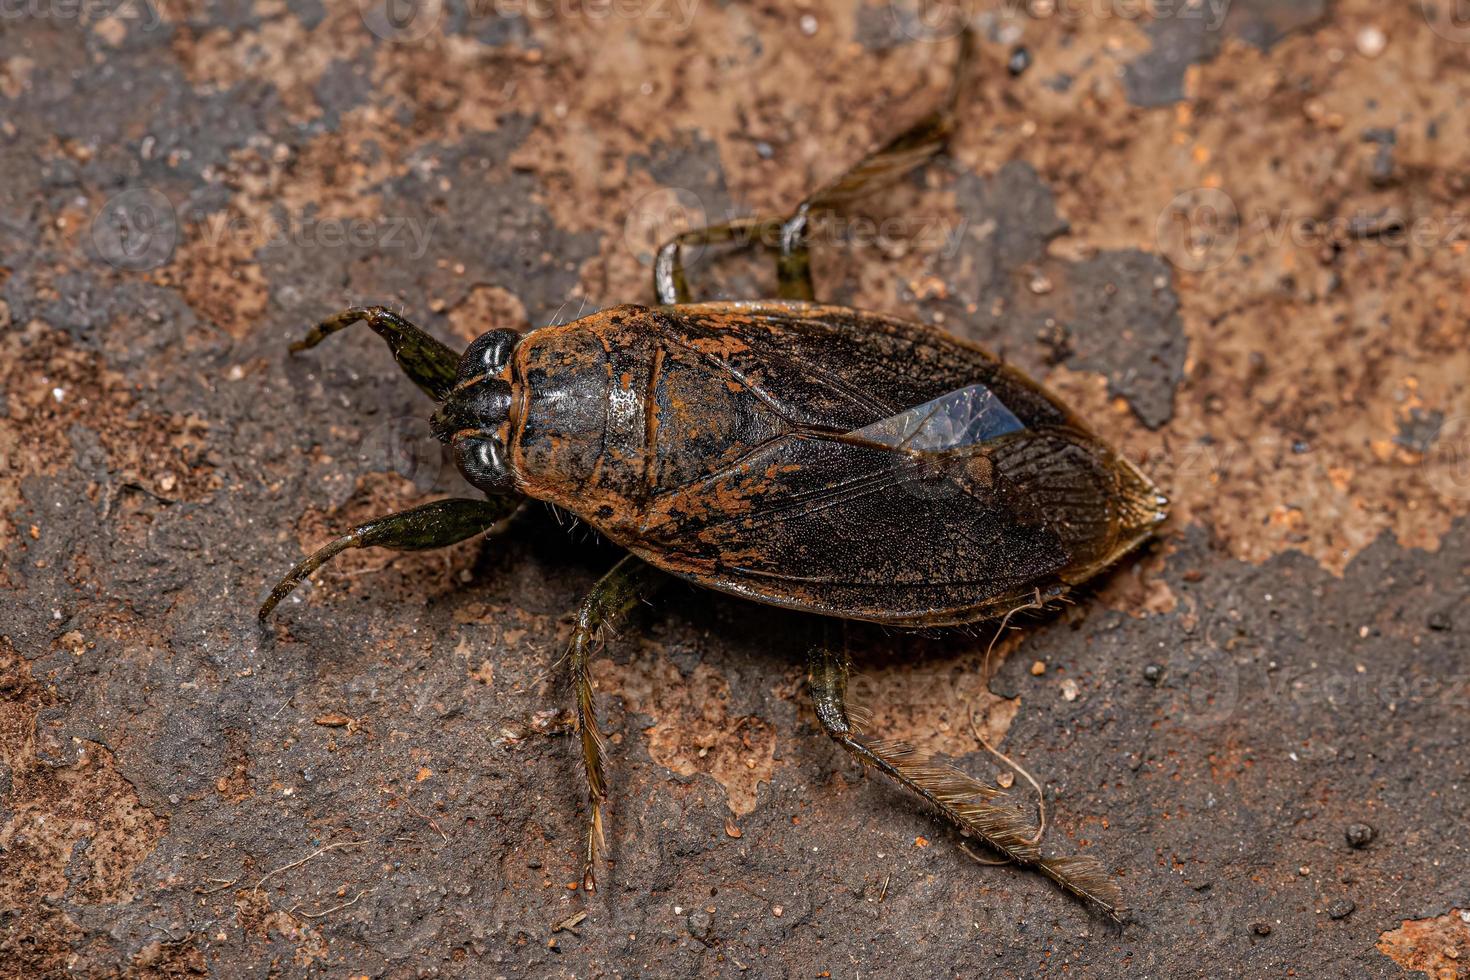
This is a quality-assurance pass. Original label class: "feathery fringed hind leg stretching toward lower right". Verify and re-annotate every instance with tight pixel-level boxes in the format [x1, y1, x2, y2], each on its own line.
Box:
[807, 648, 1123, 921]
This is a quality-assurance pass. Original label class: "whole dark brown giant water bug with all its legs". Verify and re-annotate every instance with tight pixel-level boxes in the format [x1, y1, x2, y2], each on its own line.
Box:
[260, 36, 1166, 918]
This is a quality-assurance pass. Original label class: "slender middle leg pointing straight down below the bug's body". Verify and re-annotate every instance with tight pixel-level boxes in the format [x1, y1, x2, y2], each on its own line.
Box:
[567, 555, 664, 892]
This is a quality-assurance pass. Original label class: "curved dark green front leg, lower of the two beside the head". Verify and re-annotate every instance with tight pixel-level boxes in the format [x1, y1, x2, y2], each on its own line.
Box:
[257, 497, 520, 626]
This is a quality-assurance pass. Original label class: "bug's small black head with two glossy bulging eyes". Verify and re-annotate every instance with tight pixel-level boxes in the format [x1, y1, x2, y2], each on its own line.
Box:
[431, 331, 520, 494]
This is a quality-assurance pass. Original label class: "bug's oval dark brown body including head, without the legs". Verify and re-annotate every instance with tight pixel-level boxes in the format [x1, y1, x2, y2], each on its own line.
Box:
[435, 301, 1160, 626]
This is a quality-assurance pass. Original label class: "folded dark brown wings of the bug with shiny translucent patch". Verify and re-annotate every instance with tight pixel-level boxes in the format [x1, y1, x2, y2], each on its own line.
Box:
[605, 304, 1151, 624]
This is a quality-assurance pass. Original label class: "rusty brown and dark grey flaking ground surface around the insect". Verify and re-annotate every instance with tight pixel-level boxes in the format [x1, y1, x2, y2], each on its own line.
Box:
[0, 0, 1470, 977]
